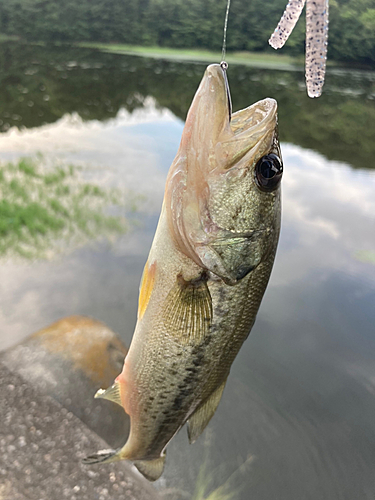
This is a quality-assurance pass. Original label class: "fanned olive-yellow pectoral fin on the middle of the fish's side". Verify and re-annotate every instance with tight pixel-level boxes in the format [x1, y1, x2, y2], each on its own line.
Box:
[162, 274, 212, 344]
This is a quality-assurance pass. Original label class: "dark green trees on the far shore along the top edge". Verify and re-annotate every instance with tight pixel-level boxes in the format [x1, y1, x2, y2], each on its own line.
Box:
[0, 0, 375, 64]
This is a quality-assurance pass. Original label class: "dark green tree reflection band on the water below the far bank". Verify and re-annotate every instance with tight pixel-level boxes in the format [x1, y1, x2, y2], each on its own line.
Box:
[0, 43, 375, 168]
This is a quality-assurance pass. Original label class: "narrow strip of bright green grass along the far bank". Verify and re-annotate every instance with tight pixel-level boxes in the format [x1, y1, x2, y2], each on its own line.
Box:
[76, 42, 303, 70]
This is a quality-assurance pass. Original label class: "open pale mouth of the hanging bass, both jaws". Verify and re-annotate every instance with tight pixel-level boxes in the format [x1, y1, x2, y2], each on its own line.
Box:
[181, 64, 277, 166]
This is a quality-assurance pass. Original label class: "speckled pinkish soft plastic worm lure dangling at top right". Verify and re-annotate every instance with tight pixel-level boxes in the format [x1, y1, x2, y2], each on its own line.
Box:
[269, 0, 328, 97]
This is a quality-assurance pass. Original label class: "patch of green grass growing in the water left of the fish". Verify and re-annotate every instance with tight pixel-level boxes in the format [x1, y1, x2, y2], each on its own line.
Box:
[0, 157, 137, 258]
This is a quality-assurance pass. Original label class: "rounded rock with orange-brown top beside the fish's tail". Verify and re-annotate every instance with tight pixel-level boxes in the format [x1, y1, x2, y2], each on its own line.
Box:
[0, 316, 129, 448]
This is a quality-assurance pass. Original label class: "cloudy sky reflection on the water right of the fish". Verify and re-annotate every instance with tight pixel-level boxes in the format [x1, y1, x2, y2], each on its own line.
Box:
[166, 145, 375, 500]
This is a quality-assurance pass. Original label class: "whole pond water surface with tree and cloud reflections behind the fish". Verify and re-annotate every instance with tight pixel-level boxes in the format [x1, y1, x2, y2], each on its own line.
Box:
[0, 44, 375, 500]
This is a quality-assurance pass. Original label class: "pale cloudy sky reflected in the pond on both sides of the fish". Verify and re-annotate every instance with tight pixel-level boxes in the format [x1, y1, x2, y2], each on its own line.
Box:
[0, 100, 375, 500]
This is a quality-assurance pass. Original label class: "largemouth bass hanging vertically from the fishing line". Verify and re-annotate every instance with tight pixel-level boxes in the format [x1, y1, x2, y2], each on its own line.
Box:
[84, 64, 283, 481]
